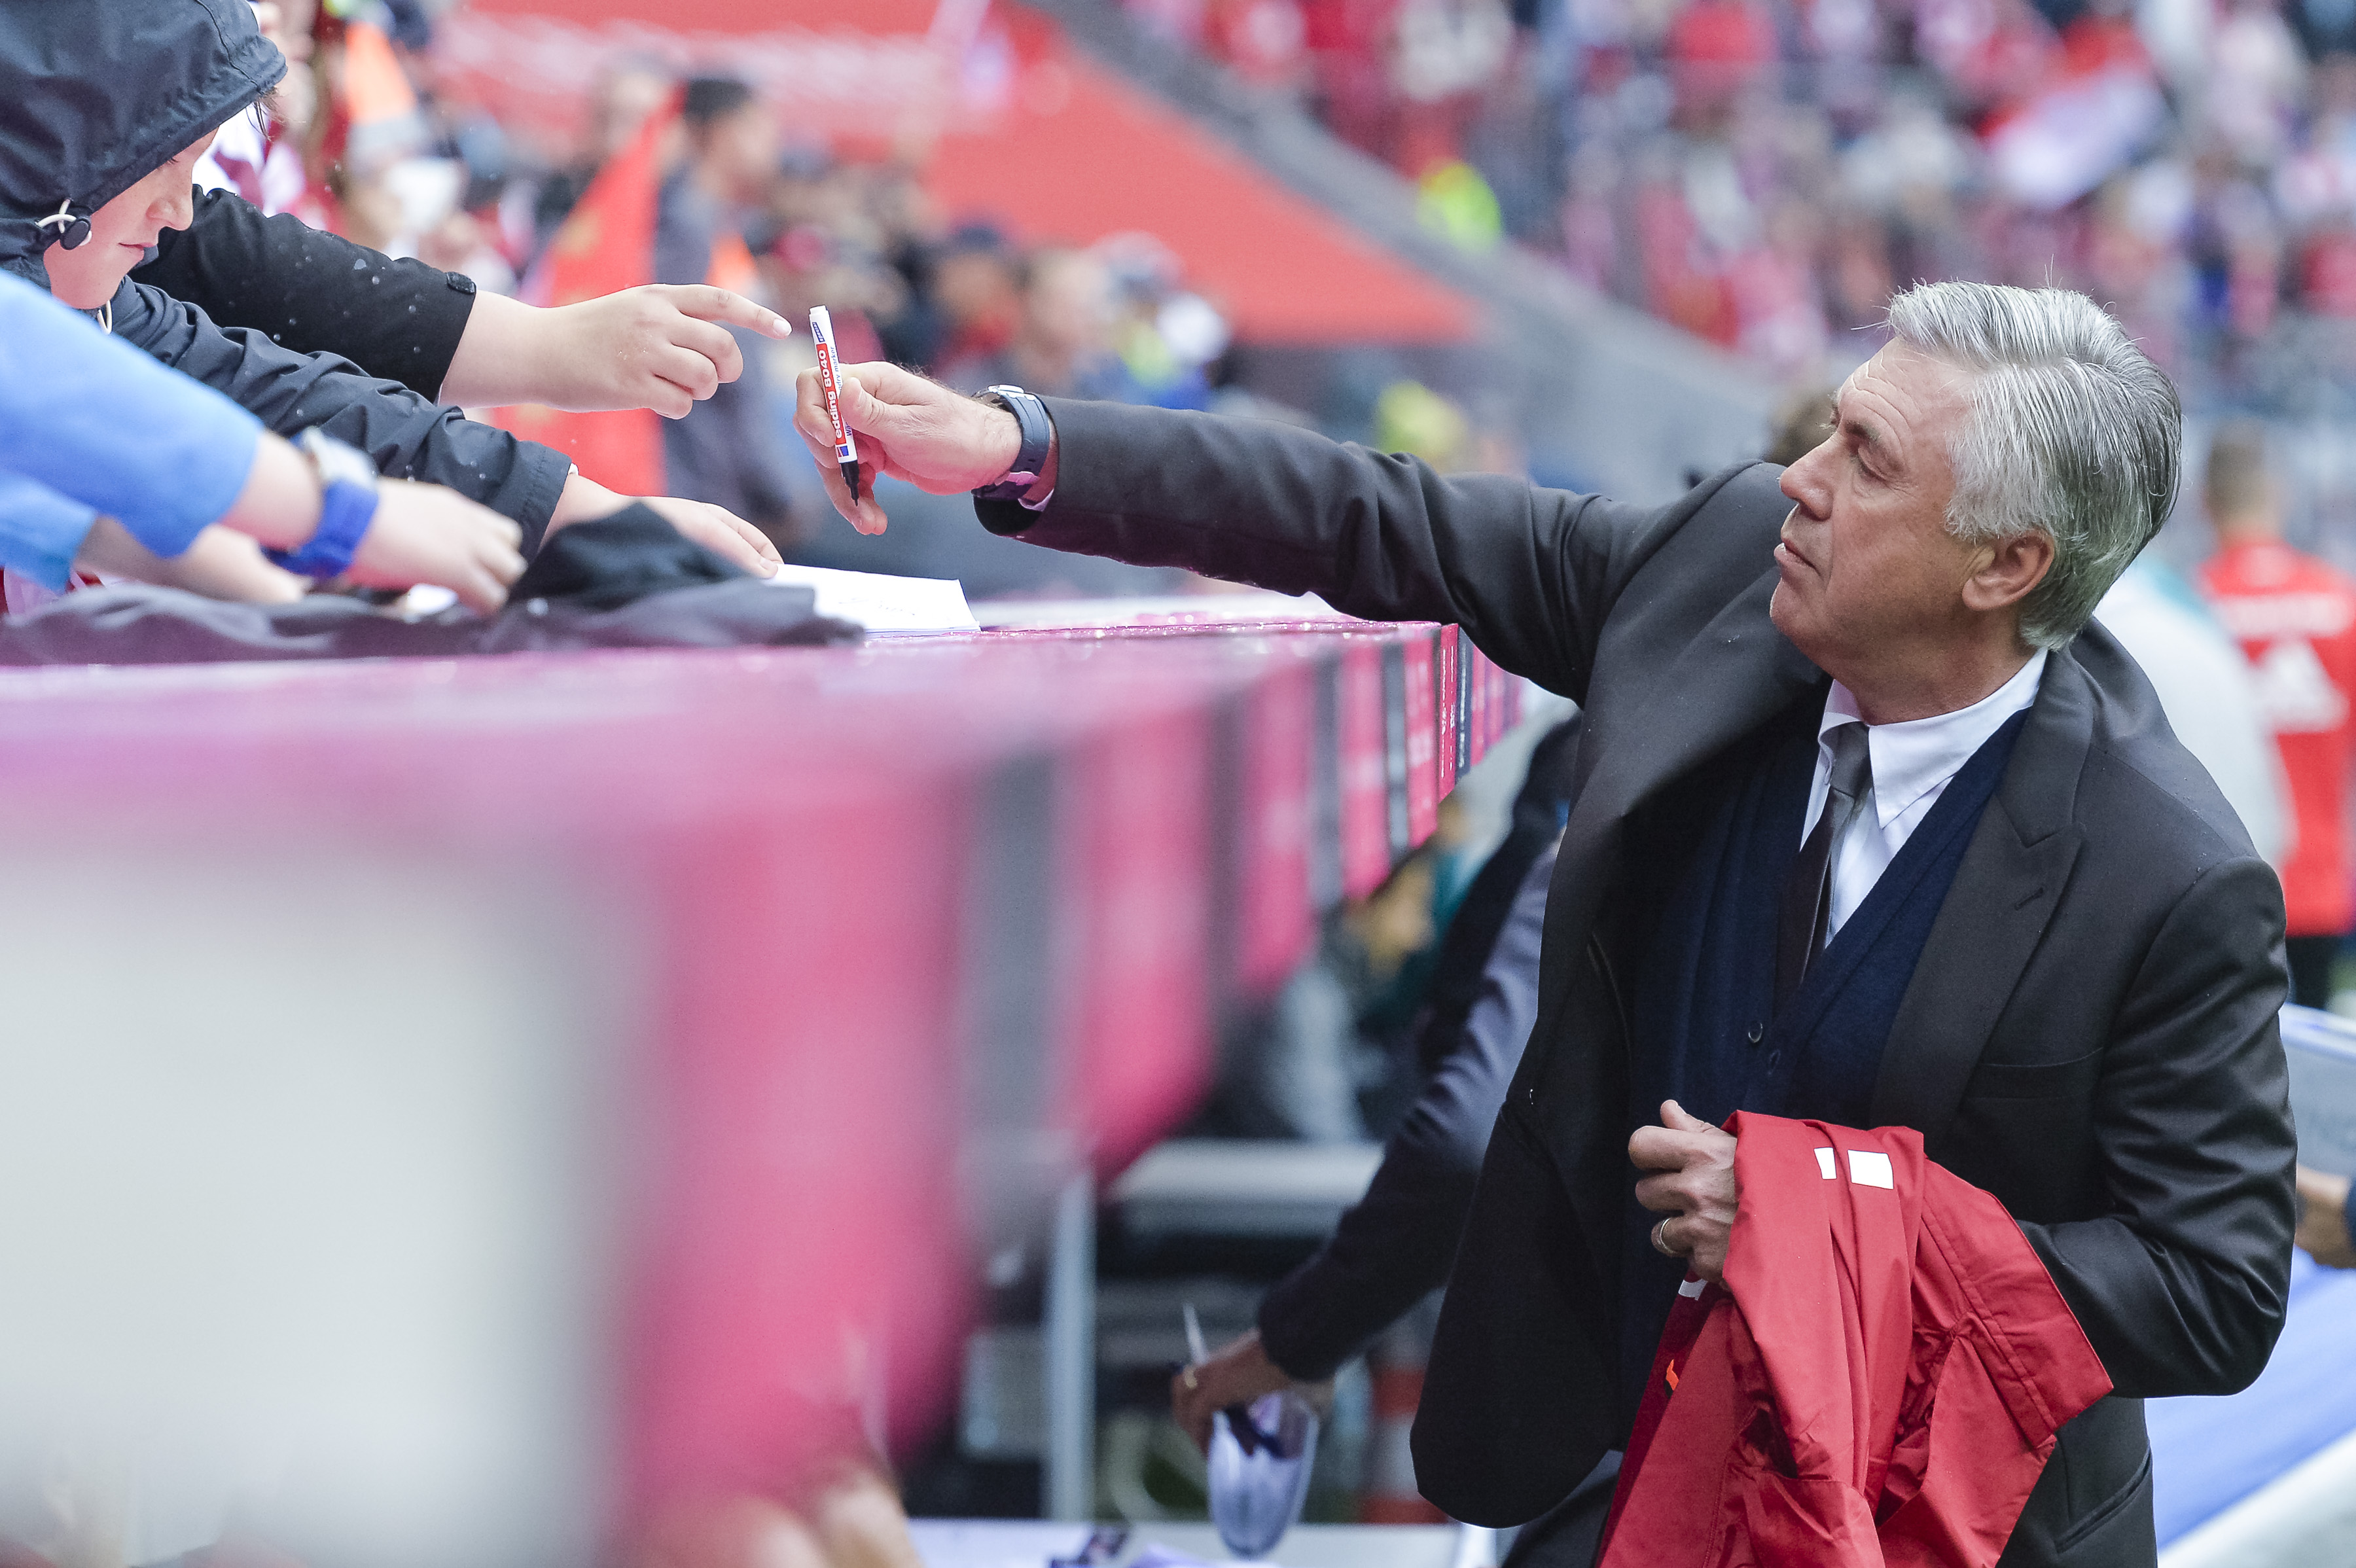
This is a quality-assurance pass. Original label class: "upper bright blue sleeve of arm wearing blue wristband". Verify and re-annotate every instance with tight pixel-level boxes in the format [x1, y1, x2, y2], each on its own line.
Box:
[0, 276, 262, 556]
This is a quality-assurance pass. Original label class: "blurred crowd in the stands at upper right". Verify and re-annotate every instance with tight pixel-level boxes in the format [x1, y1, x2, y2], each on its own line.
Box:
[1124, 0, 2356, 395]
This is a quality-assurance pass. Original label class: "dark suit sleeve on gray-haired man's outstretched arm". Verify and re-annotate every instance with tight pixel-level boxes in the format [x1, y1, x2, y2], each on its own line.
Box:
[975, 398, 1715, 702]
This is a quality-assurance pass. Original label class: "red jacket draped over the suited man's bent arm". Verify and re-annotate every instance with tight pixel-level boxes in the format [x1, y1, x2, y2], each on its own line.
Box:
[1602, 1114, 2111, 1568]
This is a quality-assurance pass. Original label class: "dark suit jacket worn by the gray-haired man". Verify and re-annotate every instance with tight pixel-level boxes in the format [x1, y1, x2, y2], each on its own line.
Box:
[982, 402, 2293, 1563]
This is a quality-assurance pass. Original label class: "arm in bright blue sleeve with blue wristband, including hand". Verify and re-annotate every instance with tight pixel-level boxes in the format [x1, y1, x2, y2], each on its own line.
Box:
[0, 273, 523, 615]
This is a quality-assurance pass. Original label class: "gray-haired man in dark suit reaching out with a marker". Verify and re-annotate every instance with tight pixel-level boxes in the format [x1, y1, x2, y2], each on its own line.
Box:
[796, 283, 2293, 1563]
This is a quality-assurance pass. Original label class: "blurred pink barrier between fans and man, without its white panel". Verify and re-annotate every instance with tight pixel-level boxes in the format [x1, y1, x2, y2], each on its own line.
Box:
[0, 622, 1517, 1530]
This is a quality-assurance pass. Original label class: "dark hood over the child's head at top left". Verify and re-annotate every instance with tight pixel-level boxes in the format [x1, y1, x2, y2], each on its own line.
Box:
[0, 0, 287, 287]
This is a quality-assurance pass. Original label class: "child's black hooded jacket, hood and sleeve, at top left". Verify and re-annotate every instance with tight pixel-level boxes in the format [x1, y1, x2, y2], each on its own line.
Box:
[0, 0, 570, 553]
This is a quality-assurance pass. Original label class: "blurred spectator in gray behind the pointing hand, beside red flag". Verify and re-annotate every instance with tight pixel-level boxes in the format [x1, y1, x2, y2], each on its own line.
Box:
[655, 75, 798, 541]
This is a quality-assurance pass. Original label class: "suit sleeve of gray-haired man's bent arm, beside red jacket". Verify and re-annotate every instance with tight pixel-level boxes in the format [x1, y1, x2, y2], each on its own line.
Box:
[2022, 857, 2294, 1399]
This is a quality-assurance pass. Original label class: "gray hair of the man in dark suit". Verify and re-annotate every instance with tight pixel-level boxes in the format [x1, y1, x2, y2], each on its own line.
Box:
[1889, 283, 2184, 647]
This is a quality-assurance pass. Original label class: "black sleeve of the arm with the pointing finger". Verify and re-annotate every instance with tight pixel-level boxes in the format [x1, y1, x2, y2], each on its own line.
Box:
[132, 190, 474, 402]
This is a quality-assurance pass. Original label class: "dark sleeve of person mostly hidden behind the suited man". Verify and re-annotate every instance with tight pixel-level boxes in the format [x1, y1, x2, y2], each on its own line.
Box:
[1260, 846, 1555, 1382]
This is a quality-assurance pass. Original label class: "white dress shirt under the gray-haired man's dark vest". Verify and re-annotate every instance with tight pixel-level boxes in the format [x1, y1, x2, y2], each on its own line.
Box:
[1800, 647, 2045, 942]
